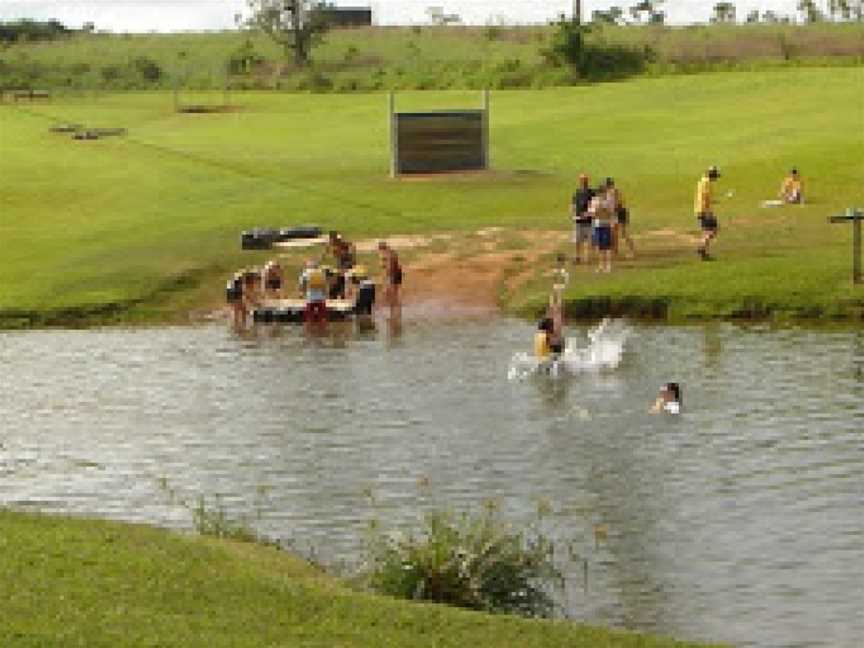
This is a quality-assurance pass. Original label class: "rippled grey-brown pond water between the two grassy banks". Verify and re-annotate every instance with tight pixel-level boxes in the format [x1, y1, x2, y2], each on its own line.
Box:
[0, 313, 864, 648]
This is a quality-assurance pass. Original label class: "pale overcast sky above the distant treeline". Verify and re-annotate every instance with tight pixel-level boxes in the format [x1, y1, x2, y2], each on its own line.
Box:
[0, 0, 827, 32]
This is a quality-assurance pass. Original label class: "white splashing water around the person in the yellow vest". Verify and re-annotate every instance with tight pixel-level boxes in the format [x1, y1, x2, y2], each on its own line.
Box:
[507, 317, 631, 380]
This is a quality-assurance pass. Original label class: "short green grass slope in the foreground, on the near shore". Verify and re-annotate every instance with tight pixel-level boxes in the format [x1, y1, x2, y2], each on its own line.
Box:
[0, 510, 724, 648]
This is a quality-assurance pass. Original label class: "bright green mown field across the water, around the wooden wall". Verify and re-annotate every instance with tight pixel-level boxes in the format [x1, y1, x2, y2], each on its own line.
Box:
[0, 67, 864, 327]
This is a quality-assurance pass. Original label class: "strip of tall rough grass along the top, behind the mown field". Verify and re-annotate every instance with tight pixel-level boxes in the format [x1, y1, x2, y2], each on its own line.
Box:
[0, 23, 864, 92]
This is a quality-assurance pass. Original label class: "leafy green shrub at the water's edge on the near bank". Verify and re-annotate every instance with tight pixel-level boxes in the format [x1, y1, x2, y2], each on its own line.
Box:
[367, 504, 563, 617]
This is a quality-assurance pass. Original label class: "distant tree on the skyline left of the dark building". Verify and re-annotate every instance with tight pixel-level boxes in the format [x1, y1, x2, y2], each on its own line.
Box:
[245, 0, 329, 66]
